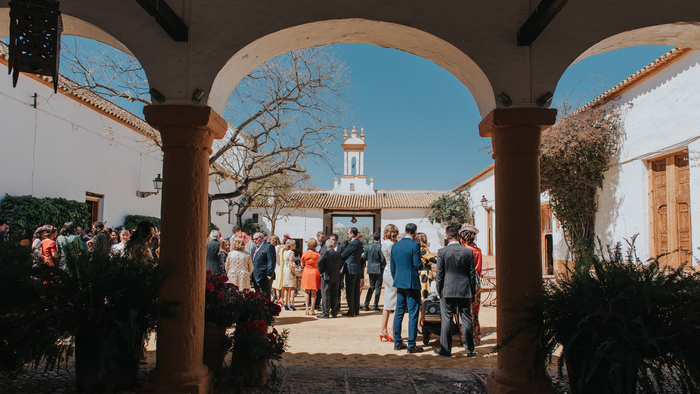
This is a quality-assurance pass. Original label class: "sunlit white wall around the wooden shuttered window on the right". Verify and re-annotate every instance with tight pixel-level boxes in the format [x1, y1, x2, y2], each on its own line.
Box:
[596, 51, 700, 259]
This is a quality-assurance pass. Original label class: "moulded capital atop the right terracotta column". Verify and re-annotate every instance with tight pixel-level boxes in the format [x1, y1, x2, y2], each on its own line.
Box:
[479, 108, 557, 137]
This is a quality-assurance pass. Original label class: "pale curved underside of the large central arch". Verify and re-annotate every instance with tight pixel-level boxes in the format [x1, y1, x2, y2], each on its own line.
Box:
[207, 19, 496, 117]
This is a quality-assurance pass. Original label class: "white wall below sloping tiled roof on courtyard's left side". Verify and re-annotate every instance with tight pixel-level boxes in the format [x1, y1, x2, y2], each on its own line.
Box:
[0, 70, 167, 226]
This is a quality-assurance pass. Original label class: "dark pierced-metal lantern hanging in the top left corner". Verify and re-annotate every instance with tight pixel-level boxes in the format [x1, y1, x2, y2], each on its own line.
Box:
[7, 0, 63, 93]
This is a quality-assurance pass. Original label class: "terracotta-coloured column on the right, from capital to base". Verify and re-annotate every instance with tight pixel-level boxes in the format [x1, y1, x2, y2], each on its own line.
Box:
[479, 108, 557, 394]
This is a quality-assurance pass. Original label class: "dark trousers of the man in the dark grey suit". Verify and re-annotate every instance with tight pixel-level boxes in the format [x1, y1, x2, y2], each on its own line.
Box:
[440, 297, 474, 354]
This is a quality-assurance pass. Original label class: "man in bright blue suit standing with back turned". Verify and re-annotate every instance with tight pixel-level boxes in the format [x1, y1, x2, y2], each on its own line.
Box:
[390, 223, 423, 353]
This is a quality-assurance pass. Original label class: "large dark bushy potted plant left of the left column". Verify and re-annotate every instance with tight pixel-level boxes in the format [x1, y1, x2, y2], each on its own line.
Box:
[2, 245, 158, 391]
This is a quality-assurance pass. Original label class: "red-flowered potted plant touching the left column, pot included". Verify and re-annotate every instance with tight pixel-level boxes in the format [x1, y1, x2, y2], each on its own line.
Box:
[203, 270, 238, 375]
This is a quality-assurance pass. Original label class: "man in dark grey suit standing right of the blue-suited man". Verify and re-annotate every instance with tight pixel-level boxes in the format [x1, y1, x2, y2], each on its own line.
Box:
[434, 226, 476, 357]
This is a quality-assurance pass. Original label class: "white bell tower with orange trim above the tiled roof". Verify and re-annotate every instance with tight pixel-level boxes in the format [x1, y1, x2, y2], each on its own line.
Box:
[333, 126, 374, 194]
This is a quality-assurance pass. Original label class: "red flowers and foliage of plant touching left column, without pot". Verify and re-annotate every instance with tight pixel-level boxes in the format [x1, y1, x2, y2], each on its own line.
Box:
[204, 270, 240, 327]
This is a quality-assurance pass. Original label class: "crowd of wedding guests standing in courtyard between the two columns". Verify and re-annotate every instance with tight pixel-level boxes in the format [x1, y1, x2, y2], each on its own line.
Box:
[206, 223, 482, 357]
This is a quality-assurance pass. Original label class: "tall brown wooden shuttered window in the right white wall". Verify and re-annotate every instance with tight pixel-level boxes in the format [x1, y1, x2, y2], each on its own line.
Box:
[648, 152, 692, 268]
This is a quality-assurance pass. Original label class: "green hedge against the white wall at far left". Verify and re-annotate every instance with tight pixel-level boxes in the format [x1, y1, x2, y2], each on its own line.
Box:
[0, 194, 90, 233]
